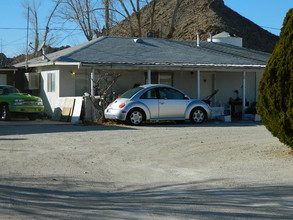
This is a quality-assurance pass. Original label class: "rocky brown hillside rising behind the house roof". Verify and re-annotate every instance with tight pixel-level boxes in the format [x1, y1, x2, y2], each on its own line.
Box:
[111, 0, 279, 52]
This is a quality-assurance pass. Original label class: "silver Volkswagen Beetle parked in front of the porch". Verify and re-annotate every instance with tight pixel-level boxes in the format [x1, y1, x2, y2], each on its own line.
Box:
[105, 84, 211, 125]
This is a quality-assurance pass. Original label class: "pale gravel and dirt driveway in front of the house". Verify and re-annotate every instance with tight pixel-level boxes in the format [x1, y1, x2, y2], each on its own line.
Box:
[0, 121, 293, 219]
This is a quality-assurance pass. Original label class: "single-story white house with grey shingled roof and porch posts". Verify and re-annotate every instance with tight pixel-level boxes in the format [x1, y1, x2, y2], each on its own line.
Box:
[16, 33, 270, 121]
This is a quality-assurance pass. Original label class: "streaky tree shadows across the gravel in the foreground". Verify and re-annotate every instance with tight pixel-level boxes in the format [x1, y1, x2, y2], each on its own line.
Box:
[0, 177, 293, 220]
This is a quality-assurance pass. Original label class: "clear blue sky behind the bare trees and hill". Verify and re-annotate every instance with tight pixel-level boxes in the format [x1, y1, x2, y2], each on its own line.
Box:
[0, 0, 293, 58]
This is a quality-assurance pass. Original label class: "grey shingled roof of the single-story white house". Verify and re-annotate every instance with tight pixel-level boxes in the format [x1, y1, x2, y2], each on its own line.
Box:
[15, 37, 270, 69]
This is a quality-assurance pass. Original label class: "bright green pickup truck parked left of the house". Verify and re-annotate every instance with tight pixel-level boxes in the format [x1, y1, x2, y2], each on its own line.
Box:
[0, 85, 44, 121]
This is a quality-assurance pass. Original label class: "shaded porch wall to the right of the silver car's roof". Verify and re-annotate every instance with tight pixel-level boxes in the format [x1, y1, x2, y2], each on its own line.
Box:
[174, 71, 262, 106]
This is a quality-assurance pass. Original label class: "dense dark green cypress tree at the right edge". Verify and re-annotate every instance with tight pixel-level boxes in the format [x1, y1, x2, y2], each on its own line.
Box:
[257, 9, 293, 150]
